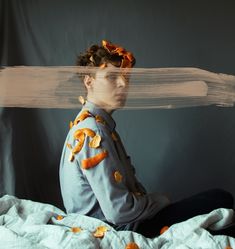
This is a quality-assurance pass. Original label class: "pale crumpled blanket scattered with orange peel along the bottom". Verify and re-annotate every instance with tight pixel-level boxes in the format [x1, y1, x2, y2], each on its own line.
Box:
[0, 195, 235, 249]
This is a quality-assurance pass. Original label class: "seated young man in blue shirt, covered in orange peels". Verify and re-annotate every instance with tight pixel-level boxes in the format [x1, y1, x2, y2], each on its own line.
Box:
[60, 40, 233, 237]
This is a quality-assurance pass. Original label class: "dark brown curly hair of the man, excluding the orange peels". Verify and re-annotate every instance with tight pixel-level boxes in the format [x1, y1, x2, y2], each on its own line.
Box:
[76, 41, 136, 79]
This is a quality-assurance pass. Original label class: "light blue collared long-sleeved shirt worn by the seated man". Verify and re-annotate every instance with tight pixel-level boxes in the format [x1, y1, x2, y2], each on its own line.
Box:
[60, 101, 169, 230]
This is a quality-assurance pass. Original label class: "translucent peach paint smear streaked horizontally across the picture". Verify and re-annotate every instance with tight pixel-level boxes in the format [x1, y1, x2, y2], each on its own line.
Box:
[0, 66, 235, 109]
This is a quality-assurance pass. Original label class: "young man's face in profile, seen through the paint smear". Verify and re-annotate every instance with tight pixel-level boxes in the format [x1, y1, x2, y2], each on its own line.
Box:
[84, 63, 129, 111]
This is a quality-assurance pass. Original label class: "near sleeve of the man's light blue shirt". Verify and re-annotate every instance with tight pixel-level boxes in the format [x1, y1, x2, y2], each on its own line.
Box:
[76, 126, 169, 225]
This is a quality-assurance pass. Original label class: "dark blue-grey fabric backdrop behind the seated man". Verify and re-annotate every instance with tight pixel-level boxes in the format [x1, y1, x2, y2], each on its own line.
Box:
[0, 0, 235, 208]
